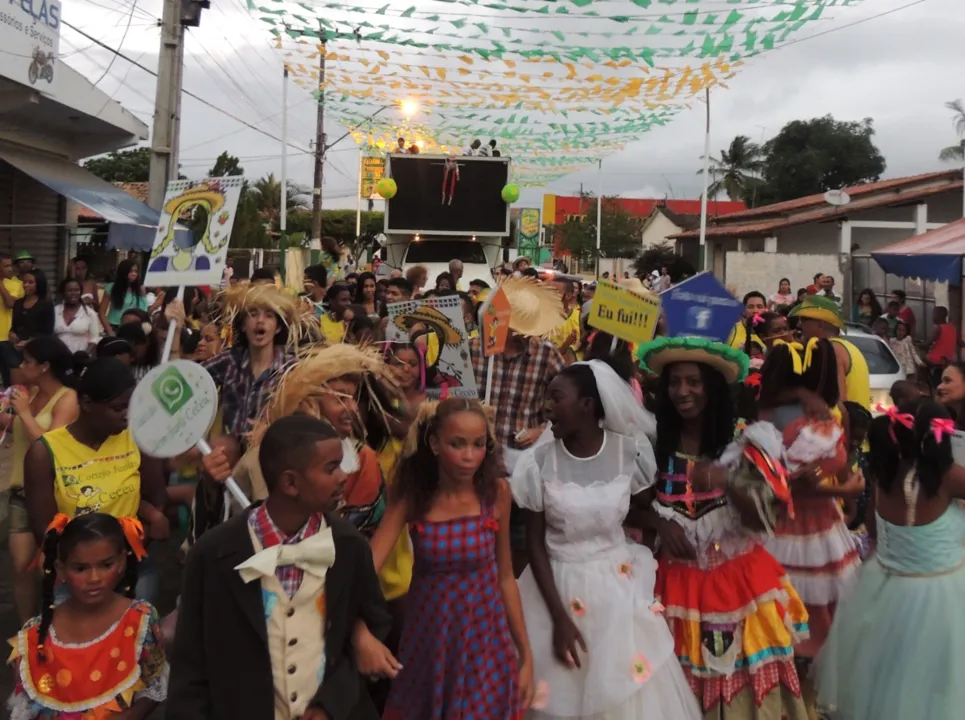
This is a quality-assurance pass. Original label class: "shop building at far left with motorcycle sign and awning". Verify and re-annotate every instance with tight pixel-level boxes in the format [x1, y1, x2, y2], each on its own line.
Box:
[0, 8, 151, 282]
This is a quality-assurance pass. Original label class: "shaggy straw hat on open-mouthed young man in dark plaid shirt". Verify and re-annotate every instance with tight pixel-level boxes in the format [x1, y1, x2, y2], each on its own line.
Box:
[218, 283, 323, 350]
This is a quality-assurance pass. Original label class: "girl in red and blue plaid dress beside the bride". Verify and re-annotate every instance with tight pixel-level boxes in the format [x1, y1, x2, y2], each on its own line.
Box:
[372, 398, 533, 720]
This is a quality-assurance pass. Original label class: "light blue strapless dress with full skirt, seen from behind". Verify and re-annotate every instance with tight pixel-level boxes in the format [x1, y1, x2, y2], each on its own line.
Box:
[817, 502, 965, 720]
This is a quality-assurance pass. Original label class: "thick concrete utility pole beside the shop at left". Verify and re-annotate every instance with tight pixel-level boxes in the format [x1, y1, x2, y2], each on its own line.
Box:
[147, 0, 211, 210]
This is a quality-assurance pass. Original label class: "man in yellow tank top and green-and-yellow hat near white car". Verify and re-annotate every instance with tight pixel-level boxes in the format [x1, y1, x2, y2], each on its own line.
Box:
[788, 295, 871, 414]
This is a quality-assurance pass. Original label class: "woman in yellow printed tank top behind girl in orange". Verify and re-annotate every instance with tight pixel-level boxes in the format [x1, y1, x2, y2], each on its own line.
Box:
[24, 357, 170, 596]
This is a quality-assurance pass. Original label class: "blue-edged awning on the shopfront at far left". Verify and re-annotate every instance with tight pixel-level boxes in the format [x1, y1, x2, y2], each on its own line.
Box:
[0, 145, 160, 250]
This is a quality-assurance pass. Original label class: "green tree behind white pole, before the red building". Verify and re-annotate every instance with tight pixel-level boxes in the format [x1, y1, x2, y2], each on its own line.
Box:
[550, 195, 646, 264]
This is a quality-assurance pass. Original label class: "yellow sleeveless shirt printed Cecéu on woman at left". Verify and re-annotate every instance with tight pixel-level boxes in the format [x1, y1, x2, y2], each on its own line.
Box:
[41, 427, 141, 518]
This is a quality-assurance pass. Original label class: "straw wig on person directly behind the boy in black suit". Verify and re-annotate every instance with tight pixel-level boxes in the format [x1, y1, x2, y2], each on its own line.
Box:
[249, 343, 400, 446]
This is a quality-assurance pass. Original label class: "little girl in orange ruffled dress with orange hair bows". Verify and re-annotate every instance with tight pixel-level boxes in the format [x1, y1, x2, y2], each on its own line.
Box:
[8, 513, 168, 720]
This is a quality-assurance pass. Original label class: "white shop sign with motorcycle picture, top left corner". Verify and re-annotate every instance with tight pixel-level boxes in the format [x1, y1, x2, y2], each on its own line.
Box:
[0, 0, 61, 95]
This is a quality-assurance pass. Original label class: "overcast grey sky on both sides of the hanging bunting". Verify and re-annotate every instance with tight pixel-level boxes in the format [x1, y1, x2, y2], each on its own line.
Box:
[60, 0, 965, 208]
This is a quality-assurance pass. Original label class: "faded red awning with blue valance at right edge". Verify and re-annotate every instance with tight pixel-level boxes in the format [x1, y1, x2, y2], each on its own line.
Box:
[871, 218, 965, 286]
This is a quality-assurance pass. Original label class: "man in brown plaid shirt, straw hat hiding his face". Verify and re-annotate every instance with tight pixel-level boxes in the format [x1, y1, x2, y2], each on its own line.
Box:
[469, 277, 566, 576]
